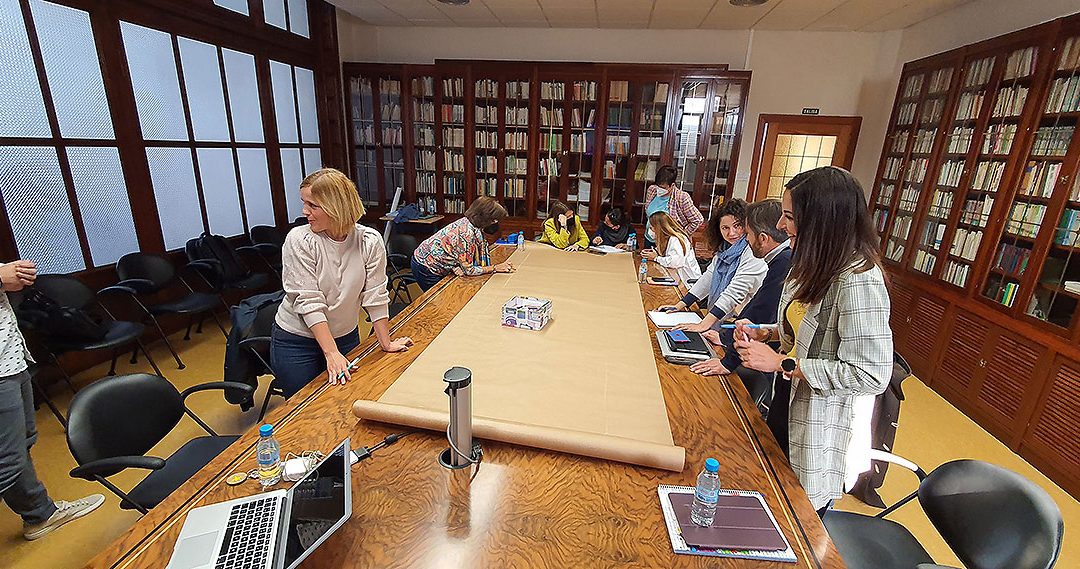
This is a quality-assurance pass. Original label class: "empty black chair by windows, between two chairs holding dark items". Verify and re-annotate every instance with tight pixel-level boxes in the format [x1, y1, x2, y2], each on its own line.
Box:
[117, 253, 228, 369]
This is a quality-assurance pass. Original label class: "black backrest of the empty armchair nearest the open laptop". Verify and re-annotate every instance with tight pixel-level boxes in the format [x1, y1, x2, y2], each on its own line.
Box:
[67, 374, 184, 475]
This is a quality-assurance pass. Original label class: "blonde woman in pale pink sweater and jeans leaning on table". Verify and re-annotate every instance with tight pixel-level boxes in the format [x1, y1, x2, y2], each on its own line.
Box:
[270, 168, 413, 397]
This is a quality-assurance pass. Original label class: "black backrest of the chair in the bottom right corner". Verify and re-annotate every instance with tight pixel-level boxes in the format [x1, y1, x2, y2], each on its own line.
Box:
[919, 460, 1065, 569]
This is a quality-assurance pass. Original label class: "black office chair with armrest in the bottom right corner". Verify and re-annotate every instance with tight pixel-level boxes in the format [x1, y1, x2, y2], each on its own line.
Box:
[822, 452, 1065, 569]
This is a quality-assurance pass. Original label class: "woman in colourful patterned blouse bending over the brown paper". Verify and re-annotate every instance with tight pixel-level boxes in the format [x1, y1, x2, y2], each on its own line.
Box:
[413, 195, 514, 290]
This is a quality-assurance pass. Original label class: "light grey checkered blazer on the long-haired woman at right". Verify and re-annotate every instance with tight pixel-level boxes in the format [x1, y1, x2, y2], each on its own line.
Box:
[778, 267, 893, 509]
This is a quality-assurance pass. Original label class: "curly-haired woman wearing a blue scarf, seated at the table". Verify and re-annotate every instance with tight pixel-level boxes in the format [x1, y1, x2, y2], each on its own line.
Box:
[662, 199, 769, 331]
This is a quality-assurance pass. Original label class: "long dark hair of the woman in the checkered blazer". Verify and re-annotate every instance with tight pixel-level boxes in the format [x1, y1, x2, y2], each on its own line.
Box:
[785, 166, 881, 304]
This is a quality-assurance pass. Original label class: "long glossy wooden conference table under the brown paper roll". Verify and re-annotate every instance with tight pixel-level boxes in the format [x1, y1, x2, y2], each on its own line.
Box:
[89, 247, 843, 569]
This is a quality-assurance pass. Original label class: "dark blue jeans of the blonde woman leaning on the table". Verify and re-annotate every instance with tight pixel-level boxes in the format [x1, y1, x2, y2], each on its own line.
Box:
[270, 323, 360, 397]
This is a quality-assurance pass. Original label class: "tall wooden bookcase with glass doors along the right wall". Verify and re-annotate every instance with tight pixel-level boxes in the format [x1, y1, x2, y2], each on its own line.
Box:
[869, 16, 1080, 496]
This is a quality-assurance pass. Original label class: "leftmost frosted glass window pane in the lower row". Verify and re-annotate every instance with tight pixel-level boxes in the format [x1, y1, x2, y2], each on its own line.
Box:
[0, 146, 86, 273]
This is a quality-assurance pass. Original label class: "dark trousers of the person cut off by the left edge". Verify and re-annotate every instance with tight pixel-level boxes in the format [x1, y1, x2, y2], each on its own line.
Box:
[0, 371, 56, 524]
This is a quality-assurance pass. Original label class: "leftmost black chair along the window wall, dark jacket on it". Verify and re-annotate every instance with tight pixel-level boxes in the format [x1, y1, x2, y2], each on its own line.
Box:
[28, 274, 162, 385]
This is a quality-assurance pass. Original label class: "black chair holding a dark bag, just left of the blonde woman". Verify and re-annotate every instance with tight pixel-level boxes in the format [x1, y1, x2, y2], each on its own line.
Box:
[184, 233, 269, 310]
